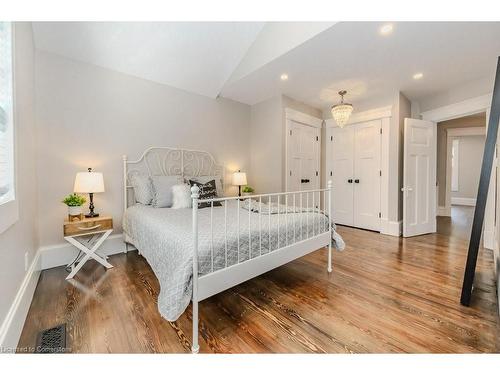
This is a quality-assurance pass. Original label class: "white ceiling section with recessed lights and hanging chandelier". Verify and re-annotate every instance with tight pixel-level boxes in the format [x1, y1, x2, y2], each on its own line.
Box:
[222, 22, 500, 108]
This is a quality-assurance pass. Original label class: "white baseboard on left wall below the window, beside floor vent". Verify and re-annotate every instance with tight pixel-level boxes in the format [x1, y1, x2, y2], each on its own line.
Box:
[0, 251, 40, 353]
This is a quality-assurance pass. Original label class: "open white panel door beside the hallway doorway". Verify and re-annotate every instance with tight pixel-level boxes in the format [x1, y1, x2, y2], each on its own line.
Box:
[401, 118, 436, 237]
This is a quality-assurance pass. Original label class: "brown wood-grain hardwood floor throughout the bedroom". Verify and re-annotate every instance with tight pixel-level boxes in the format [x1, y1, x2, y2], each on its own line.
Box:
[19, 209, 500, 353]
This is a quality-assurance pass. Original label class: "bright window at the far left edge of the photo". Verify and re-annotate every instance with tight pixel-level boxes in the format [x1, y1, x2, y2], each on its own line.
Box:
[0, 22, 15, 206]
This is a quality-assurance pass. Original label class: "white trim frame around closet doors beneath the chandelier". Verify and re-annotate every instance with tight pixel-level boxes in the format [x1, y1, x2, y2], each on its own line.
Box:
[324, 106, 394, 237]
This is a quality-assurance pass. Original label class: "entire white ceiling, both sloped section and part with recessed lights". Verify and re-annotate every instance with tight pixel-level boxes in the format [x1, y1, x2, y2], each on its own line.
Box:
[33, 22, 500, 108]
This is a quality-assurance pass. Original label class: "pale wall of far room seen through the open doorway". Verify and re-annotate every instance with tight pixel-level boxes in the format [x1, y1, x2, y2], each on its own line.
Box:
[451, 135, 485, 199]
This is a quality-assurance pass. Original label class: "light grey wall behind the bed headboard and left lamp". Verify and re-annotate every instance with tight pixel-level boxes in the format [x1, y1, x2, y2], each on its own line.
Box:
[36, 51, 250, 250]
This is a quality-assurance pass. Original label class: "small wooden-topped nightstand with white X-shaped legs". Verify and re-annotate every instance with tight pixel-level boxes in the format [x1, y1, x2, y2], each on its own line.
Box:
[64, 216, 113, 280]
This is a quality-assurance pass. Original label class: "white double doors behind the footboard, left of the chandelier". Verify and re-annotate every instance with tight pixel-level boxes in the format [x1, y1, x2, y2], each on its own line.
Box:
[287, 120, 321, 200]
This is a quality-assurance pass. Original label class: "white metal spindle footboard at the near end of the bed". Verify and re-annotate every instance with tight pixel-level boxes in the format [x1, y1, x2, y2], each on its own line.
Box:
[191, 181, 332, 353]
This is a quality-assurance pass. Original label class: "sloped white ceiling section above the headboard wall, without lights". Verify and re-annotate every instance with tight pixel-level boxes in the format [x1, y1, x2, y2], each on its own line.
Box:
[33, 22, 264, 98]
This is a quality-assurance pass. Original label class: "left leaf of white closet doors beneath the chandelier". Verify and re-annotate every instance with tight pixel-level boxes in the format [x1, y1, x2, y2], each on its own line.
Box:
[332, 126, 354, 226]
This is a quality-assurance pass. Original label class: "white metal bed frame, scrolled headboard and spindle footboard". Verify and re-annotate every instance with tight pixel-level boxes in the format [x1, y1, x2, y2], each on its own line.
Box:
[123, 147, 332, 353]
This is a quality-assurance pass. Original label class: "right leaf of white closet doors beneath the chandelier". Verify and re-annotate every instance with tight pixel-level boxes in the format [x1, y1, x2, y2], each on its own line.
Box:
[353, 120, 382, 231]
